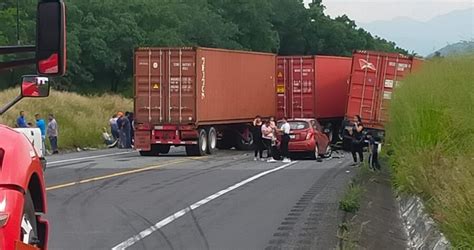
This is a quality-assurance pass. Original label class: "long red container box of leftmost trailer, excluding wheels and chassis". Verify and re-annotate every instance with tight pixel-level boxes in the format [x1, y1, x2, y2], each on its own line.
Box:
[135, 48, 275, 125]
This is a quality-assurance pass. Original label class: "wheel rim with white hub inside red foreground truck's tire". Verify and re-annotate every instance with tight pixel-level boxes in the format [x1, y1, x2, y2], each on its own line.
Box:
[20, 192, 38, 244]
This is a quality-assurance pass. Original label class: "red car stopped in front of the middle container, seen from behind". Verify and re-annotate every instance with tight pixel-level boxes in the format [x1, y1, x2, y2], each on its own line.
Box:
[278, 118, 332, 159]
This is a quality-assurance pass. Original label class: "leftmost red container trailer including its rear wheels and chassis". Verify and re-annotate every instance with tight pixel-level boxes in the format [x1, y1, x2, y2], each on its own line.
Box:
[134, 48, 276, 156]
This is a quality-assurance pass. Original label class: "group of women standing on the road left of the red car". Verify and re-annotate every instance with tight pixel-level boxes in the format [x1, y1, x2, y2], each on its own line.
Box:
[252, 116, 291, 163]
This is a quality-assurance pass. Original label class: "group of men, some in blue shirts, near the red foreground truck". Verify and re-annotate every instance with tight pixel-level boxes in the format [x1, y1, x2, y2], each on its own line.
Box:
[15, 111, 59, 154]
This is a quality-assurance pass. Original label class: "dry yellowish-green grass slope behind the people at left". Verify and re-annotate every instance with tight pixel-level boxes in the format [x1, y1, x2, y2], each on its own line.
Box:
[0, 89, 133, 149]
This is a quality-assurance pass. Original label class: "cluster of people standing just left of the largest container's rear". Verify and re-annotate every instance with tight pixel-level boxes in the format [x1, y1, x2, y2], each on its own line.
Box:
[109, 111, 135, 148]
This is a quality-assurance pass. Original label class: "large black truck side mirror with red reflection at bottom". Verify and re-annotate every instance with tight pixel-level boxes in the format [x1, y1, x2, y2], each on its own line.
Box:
[36, 0, 66, 76]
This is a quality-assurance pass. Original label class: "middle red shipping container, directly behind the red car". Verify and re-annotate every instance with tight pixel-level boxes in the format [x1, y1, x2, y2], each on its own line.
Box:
[276, 56, 352, 119]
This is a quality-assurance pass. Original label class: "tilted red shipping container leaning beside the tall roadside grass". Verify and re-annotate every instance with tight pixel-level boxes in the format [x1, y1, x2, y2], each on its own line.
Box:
[346, 51, 421, 130]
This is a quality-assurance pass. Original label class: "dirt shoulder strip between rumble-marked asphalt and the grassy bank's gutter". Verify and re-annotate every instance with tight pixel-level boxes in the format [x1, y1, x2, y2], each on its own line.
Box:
[339, 167, 408, 249]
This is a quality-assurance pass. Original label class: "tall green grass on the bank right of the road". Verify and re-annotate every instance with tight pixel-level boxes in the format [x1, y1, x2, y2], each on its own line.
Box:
[386, 55, 474, 248]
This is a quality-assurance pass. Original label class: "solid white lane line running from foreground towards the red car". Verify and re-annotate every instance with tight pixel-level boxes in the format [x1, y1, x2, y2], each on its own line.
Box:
[112, 161, 297, 250]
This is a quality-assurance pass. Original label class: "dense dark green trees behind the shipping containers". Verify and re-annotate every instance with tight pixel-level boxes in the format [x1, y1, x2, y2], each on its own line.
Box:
[0, 0, 406, 93]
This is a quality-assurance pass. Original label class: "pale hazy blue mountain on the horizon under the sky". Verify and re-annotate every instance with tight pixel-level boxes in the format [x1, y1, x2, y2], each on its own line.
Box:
[358, 8, 474, 56]
